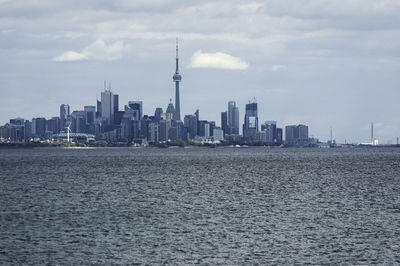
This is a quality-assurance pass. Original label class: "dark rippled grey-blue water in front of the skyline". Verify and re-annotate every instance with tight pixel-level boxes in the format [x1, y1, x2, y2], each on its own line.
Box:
[0, 148, 400, 265]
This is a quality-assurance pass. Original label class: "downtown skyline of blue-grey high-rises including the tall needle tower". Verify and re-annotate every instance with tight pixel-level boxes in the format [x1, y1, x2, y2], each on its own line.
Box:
[0, 40, 316, 146]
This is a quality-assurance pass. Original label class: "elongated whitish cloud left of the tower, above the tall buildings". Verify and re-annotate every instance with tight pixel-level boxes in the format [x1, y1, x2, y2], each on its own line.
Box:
[53, 40, 125, 62]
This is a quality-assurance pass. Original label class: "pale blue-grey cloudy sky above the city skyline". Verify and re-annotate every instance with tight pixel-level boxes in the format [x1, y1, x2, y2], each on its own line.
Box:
[0, 0, 400, 143]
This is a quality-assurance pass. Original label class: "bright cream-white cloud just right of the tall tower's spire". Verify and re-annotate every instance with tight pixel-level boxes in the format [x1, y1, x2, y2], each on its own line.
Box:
[189, 50, 249, 70]
